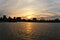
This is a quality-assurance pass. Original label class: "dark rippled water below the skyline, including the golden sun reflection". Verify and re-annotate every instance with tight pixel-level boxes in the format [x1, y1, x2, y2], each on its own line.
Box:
[0, 22, 60, 40]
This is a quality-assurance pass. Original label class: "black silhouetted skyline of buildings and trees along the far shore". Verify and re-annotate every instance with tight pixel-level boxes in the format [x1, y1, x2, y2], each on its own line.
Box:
[0, 15, 60, 22]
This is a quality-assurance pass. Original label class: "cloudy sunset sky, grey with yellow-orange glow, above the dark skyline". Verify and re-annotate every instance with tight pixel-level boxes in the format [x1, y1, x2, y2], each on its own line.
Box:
[0, 0, 60, 18]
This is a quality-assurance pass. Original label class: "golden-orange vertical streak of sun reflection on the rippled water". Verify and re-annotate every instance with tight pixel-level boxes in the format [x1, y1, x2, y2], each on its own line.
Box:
[25, 23, 33, 40]
